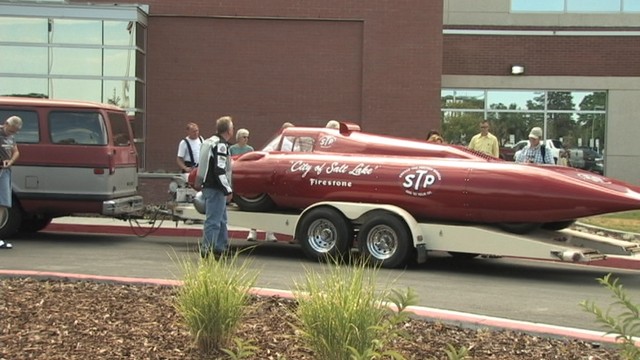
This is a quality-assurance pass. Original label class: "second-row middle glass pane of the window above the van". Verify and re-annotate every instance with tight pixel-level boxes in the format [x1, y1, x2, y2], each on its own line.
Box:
[50, 48, 102, 76]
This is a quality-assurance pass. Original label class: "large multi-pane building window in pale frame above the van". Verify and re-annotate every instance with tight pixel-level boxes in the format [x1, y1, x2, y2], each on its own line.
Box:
[0, 3, 147, 168]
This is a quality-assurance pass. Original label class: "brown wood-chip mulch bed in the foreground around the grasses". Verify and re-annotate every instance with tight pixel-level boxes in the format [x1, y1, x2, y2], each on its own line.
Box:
[0, 278, 619, 360]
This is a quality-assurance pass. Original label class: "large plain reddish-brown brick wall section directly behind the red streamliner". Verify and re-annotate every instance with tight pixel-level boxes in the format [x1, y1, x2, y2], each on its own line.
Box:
[77, 0, 443, 171]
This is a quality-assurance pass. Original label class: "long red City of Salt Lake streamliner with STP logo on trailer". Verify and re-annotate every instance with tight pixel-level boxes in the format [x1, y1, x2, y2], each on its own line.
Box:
[233, 123, 640, 233]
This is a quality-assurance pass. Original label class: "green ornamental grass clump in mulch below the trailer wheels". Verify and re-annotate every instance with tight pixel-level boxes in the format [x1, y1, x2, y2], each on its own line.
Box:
[295, 261, 413, 360]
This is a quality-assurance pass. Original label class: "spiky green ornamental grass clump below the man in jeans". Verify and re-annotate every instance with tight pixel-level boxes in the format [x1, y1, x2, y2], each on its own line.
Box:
[175, 253, 257, 353]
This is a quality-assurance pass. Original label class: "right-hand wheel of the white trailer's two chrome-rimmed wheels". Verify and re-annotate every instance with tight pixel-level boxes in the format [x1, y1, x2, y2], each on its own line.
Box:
[358, 214, 413, 268]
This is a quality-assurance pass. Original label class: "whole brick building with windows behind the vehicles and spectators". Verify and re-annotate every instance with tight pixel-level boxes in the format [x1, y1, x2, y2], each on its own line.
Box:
[0, 0, 640, 184]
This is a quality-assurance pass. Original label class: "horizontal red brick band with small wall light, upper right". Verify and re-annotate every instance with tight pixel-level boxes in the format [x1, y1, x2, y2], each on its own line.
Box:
[443, 29, 640, 76]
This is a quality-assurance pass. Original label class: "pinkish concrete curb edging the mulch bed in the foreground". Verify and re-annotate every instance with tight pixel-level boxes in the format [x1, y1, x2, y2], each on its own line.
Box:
[0, 270, 617, 344]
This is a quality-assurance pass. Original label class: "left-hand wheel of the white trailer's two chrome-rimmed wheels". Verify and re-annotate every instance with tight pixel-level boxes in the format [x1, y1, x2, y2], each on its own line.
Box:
[296, 207, 353, 260]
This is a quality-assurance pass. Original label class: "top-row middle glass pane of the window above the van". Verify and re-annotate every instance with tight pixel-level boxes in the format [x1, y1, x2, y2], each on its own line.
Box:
[51, 19, 102, 45]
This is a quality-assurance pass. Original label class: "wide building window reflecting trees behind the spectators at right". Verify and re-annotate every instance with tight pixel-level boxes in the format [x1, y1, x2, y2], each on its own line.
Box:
[441, 89, 607, 162]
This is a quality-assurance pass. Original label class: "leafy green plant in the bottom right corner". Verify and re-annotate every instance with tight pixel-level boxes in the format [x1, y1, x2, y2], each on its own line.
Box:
[580, 274, 640, 360]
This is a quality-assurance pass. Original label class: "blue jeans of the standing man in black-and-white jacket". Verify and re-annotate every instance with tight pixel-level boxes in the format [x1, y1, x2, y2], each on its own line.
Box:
[200, 188, 229, 253]
